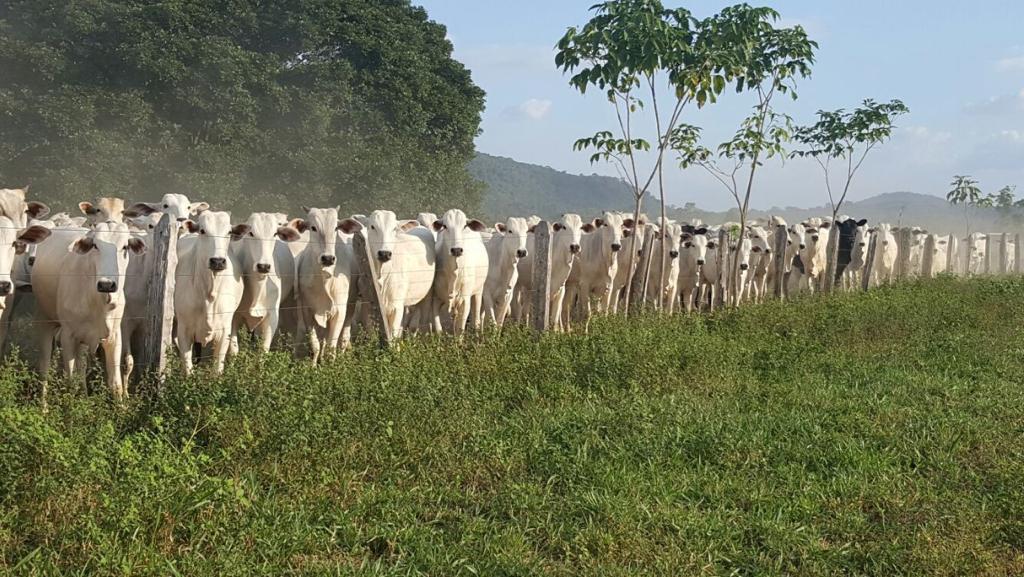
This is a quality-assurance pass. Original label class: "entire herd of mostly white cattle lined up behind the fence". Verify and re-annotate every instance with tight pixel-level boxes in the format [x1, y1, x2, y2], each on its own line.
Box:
[0, 189, 1014, 399]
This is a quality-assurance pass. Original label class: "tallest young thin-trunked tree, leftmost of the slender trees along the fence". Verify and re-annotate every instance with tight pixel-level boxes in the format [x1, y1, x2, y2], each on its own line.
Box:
[555, 0, 726, 311]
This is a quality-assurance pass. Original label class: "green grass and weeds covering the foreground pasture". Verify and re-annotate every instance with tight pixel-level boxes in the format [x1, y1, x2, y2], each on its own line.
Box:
[0, 279, 1024, 576]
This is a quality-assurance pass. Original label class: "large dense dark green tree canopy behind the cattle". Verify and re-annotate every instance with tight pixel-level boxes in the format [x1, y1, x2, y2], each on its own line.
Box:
[0, 0, 483, 211]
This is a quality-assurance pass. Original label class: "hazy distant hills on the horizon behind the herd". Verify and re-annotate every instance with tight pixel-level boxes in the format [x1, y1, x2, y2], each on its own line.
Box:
[469, 153, 1022, 234]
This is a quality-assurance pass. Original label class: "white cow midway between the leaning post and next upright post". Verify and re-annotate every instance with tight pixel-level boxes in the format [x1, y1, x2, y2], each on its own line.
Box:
[431, 208, 488, 335]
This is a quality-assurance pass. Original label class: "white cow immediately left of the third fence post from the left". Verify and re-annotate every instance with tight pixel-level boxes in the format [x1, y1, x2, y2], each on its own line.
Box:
[483, 217, 529, 328]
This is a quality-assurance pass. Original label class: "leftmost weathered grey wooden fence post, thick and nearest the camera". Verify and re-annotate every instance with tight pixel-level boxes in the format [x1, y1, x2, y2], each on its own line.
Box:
[138, 213, 178, 387]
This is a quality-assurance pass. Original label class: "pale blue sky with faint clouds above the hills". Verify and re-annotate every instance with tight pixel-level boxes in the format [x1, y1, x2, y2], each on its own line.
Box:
[414, 0, 1024, 208]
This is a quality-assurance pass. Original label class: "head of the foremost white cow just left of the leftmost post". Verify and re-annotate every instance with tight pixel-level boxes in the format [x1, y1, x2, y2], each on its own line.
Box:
[70, 222, 145, 304]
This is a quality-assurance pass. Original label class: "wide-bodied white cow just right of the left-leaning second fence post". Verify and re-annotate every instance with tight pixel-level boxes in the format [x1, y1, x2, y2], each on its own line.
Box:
[341, 210, 436, 339]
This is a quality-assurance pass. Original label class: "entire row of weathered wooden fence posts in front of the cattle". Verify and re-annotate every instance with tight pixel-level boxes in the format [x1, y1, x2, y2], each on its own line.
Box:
[136, 214, 1024, 377]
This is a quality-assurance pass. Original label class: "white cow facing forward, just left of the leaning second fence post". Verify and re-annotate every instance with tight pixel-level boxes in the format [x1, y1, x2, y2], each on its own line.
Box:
[291, 207, 358, 363]
